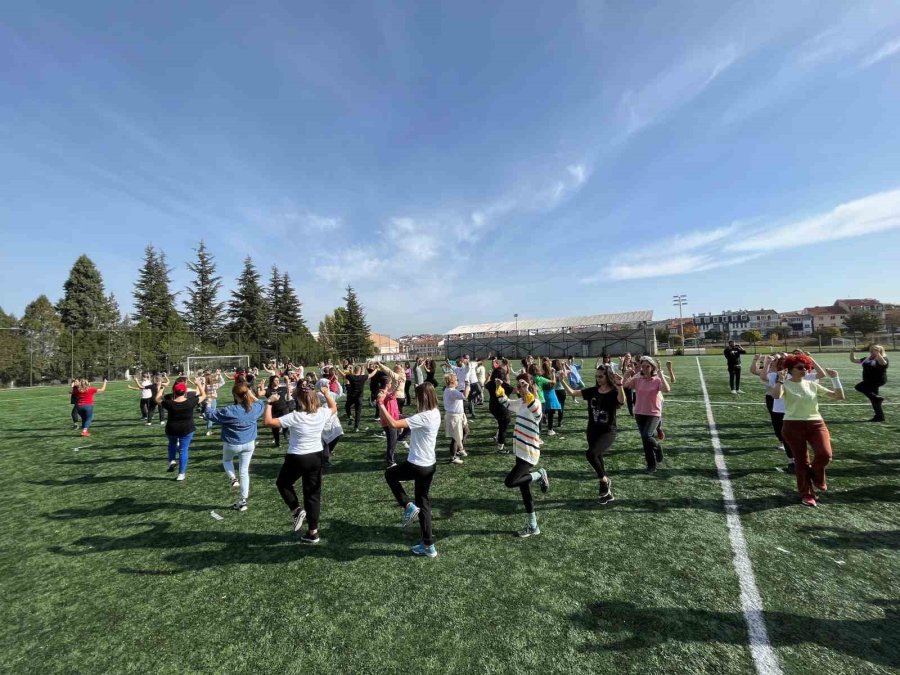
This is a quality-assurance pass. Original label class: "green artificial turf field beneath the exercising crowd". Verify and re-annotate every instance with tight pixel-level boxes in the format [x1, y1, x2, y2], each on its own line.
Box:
[0, 355, 900, 675]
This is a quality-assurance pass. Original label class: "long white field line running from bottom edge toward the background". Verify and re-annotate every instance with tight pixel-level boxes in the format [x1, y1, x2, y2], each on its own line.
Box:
[697, 358, 782, 675]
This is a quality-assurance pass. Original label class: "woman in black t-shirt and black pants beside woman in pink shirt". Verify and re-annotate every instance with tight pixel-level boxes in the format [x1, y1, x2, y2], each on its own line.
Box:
[563, 364, 625, 504]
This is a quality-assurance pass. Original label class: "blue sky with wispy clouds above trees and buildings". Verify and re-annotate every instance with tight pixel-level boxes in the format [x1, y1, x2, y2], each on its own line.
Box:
[0, 0, 900, 335]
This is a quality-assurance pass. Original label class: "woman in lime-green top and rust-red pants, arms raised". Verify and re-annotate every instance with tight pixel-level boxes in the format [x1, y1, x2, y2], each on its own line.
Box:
[772, 354, 844, 506]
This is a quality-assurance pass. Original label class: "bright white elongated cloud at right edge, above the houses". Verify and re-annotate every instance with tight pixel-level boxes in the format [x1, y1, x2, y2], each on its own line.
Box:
[724, 189, 900, 251]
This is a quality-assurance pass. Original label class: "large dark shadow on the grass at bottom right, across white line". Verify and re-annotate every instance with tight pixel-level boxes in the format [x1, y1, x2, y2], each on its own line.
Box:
[571, 599, 900, 668]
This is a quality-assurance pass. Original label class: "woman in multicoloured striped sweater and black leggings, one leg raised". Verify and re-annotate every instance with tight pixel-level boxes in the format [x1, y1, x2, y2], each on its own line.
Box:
[494, 373, 550, 537]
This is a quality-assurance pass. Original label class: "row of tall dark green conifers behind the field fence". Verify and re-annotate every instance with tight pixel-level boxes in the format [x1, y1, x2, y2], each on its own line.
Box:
[0, 241, 375, 382]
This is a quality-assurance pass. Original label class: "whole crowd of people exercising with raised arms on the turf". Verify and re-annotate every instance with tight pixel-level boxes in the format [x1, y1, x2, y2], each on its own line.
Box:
[71, 342, 888, 557]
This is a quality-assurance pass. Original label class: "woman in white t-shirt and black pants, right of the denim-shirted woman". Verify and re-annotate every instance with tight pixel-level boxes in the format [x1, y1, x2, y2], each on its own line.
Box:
[263, 382, 337, 544]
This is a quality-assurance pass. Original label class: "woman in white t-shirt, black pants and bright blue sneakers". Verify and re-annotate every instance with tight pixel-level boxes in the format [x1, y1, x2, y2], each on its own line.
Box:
[378, 382, 441, 558]
